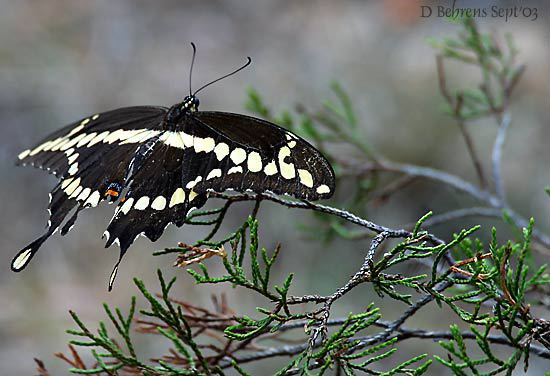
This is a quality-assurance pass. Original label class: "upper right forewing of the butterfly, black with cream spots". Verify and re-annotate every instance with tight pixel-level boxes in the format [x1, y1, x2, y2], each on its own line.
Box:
[184, 112, 335, 200]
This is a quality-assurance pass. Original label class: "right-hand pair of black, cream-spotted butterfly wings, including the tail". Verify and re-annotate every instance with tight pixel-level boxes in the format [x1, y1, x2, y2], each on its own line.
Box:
[105, 112, 334, 287]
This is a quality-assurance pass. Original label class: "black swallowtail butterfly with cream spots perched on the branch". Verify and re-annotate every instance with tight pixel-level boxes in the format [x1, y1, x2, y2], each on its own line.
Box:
[11, 43, 335, 290]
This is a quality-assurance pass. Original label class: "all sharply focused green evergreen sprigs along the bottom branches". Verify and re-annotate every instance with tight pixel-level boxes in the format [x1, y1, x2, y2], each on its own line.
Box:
[58, 212, 550, 375]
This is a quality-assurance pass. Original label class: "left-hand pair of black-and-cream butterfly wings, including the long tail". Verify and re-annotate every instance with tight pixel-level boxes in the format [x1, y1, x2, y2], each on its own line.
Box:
[11, 107, 166, 271]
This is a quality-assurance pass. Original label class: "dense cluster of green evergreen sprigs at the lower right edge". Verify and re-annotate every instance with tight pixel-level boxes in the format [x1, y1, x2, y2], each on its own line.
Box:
[436, 221, 550, 375]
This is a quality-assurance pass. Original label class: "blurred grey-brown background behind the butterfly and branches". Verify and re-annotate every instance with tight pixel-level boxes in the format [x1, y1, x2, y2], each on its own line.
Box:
[0, 0, 550, 375]
